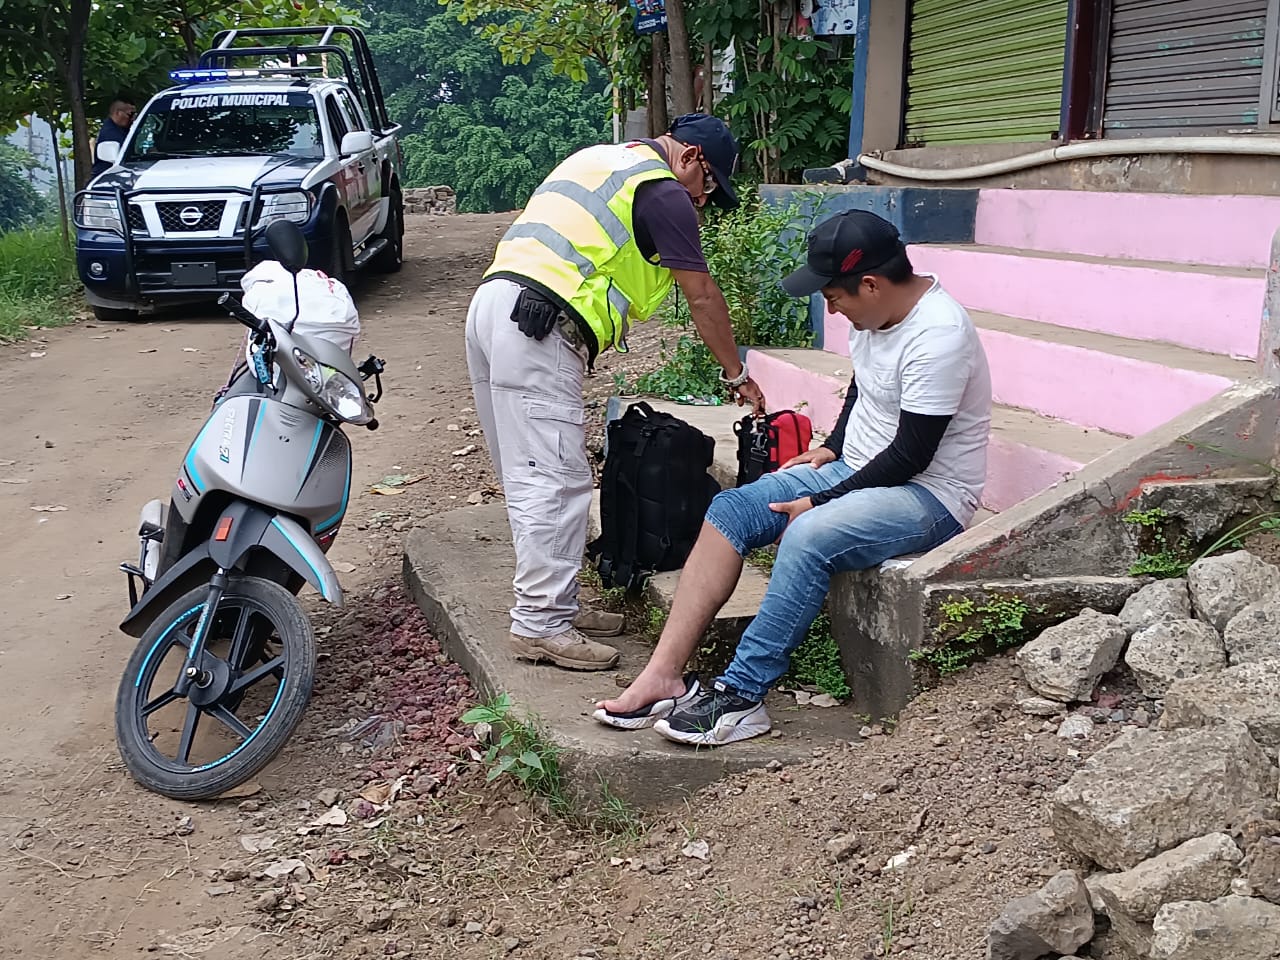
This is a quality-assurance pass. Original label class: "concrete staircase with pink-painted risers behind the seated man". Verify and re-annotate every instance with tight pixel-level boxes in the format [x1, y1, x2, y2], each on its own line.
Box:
[650, 187, 1280, 716]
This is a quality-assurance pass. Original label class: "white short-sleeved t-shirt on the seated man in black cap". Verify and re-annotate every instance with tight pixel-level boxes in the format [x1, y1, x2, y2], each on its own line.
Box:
[844, 274, 991, 525]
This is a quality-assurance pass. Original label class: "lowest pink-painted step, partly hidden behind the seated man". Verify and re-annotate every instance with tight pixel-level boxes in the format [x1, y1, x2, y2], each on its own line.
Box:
[746, 349, 1124, 512]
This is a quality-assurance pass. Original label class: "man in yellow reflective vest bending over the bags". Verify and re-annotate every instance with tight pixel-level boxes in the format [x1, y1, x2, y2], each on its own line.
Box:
[466, 114, 764, 669]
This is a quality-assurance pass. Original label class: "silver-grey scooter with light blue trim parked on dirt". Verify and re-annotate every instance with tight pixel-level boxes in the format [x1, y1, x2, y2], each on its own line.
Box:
[115, 221, 385, 800]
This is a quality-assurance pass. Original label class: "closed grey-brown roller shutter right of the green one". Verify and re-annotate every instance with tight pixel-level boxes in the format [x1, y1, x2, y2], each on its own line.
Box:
[1102, 0, 1270, 137]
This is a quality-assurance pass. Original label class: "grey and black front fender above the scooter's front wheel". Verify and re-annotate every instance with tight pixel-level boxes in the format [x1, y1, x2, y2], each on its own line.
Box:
[120, 500, 343, 636]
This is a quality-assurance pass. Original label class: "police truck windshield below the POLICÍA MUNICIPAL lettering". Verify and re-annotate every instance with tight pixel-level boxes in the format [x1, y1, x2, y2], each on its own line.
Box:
[124, 92, 324, 163]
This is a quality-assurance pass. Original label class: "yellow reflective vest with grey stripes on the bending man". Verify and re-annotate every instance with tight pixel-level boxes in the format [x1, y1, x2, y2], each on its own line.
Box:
[485, 143, 675, 351]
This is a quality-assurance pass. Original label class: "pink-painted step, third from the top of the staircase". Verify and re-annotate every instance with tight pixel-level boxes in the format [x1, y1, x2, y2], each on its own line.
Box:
[827, 311, 1256, 436]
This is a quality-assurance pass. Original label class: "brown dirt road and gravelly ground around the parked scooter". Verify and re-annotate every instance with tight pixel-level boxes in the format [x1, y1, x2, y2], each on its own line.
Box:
[0, 215, 1137, 960]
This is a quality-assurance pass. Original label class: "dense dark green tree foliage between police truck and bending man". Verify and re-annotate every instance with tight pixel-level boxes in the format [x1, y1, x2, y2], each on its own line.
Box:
[367, 0, 609, 212]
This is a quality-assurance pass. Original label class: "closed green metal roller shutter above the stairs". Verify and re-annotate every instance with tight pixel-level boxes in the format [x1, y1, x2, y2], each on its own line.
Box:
[904, 0, 1069, 146]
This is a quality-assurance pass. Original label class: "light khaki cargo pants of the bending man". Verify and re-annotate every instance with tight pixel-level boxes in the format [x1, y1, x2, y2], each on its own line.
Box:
[466, 279, 593, 636]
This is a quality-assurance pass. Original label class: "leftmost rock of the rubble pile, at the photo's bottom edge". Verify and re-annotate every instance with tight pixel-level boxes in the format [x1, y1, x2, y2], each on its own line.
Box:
[987, 870, 1093, 960]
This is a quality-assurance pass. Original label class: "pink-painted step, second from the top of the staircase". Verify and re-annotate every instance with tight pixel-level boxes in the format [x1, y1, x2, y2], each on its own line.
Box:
[910, 244, 1266, 358]
